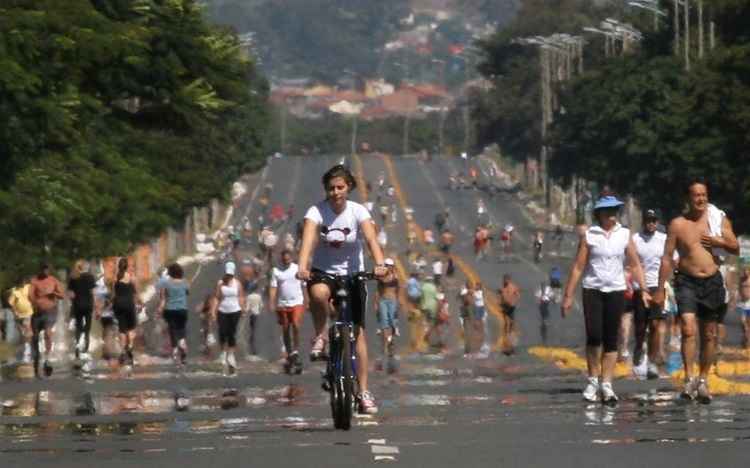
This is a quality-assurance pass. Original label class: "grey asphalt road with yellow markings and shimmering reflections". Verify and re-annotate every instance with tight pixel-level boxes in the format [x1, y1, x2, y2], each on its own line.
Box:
[0, 155, 750, 468]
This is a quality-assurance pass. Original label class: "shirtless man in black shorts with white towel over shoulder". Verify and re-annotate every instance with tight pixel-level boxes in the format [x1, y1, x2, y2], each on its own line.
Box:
[654, 179, 739, 404]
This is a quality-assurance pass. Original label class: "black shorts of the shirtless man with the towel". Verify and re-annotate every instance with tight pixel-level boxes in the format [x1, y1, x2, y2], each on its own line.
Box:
[674, 271, 727, 323]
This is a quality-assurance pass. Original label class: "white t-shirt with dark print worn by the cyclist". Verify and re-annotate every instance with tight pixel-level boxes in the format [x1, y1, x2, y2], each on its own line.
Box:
[305, 200, 372, 275]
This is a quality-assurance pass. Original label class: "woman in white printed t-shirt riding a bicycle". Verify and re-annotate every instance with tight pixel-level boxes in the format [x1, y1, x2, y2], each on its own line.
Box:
[297, 165, 387, 414]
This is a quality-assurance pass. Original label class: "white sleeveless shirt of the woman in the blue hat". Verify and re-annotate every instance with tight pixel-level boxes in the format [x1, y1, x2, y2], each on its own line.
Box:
[583, 223, 630, 292]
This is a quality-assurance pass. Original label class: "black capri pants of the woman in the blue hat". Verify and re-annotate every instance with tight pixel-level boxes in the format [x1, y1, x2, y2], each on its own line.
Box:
[583, 289, 625, 353]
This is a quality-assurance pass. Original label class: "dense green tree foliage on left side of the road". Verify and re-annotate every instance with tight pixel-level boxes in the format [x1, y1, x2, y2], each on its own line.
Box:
[0, 0, 267, 284]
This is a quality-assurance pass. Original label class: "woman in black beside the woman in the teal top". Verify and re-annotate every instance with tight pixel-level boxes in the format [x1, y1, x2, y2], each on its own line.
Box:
[112, 257, 143, 366]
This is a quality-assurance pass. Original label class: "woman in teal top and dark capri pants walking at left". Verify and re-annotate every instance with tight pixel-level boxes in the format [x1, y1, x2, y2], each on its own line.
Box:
[158, 263, 190, 366]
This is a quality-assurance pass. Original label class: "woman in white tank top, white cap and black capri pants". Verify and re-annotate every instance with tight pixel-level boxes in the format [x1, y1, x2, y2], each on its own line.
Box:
[211, 262, 245, 375]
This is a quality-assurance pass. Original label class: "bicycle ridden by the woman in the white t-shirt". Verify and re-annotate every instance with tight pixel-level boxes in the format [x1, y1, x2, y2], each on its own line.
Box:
[311, 271, 375, 431]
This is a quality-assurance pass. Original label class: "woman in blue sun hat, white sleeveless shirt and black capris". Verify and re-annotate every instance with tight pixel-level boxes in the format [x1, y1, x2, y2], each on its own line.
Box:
[562, 195, 651, 403]
